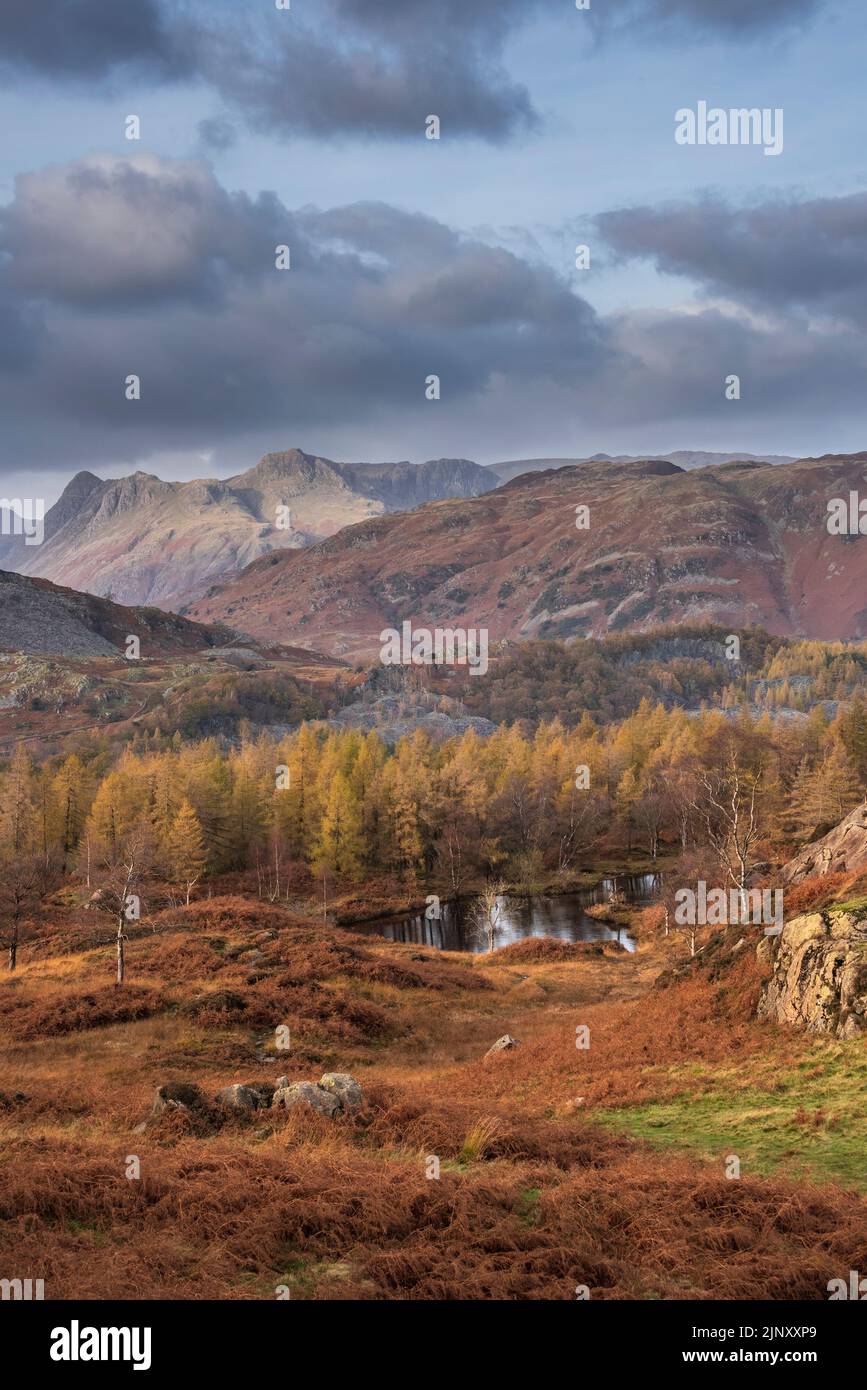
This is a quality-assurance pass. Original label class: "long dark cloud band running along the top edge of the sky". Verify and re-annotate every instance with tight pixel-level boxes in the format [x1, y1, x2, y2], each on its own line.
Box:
[0, 0, 825, 149]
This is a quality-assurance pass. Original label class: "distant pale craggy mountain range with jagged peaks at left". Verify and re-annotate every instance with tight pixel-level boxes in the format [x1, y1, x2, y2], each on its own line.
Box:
[0, 449, 497, 609]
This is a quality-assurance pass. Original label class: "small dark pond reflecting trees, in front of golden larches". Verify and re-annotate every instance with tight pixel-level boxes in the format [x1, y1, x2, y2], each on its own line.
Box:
[352, 873, 660, 952]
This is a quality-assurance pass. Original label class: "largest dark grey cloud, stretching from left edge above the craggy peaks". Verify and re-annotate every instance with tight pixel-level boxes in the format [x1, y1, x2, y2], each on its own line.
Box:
[0, 156, 607, 455]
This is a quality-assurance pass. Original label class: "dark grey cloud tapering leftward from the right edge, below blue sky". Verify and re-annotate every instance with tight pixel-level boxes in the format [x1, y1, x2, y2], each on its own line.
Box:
[596, 193, 867, 328]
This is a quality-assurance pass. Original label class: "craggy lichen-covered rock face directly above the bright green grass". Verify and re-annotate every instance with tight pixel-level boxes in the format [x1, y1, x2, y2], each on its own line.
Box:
[759, 904, 867, 1038]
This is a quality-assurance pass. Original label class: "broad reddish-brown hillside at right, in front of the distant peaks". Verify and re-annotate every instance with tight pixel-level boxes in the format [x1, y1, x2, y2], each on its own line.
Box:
[189, 453, 867, 657]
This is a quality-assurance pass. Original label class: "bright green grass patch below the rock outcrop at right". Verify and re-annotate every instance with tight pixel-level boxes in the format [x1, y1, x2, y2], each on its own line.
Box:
[595, 1041, 867, 1191]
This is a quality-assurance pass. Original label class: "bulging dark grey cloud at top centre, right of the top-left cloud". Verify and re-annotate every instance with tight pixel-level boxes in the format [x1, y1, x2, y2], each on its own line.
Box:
[197, 0, 542, 142]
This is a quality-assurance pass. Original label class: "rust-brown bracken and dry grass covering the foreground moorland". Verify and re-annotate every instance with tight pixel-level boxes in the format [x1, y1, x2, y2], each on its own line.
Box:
[0, 899, 867, 1300]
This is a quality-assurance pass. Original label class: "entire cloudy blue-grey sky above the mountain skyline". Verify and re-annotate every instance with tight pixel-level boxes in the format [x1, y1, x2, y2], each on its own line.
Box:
[0, 0, 867, 502]
